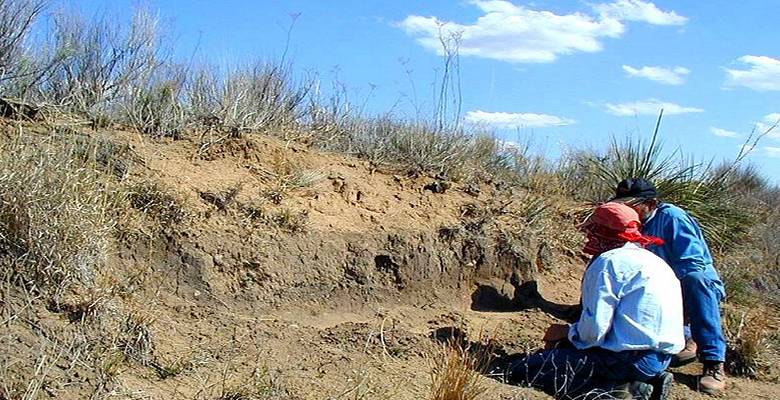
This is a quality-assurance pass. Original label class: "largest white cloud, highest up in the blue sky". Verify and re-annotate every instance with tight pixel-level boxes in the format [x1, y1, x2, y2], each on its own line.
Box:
[399, 0, 676, 63]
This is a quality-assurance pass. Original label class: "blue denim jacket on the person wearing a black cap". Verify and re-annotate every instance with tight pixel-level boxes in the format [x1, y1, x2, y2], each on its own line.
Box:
[642, 203, 723, 292]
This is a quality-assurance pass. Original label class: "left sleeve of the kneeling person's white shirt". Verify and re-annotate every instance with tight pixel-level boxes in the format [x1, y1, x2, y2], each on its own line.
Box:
[569, 258, 619, 349]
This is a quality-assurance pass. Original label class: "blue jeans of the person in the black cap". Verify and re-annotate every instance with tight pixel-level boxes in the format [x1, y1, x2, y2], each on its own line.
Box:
[680, 271, 726, 362]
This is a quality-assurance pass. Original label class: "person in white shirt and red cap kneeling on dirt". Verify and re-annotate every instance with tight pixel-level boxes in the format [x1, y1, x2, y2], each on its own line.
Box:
[505, 203, 685, 399]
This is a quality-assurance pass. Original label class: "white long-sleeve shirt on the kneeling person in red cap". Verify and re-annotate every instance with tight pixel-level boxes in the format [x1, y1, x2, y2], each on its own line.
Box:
[569, 243, 685, 354]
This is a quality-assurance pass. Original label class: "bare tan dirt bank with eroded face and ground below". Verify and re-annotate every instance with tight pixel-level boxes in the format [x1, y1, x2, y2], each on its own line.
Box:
[0, 126, 780, 399]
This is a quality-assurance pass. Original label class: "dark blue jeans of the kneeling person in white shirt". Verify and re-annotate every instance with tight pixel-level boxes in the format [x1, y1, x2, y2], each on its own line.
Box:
[506, 347, 672, 397]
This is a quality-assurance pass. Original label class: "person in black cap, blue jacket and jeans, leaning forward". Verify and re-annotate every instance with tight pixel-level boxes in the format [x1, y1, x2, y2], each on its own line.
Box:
[611, 178, 726, 395]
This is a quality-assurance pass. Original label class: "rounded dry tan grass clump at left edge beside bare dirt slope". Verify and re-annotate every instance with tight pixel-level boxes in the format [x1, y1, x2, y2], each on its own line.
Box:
[0, 137, 118, 294]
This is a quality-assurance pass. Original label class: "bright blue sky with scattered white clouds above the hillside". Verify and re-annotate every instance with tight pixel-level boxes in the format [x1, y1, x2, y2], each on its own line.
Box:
[73, 0, 780, 183]
